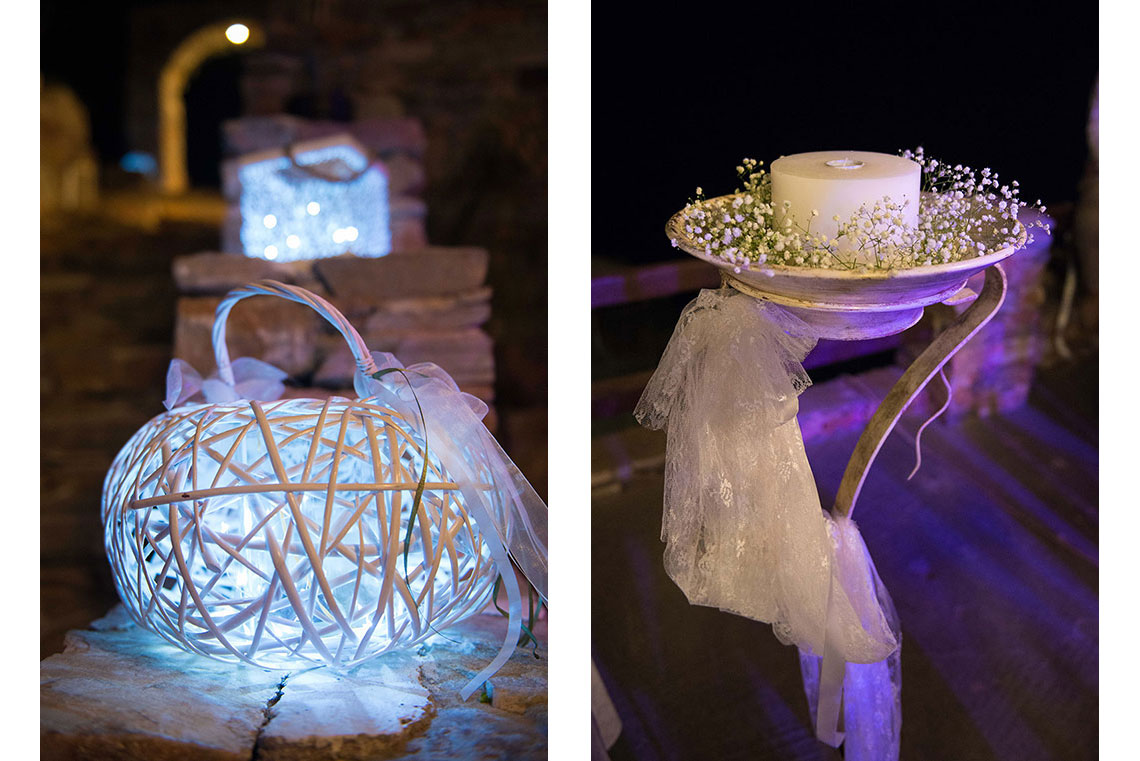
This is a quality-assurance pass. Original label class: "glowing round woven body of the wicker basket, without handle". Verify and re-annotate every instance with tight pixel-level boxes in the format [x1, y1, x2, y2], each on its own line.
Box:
[103, 400, 499, 668]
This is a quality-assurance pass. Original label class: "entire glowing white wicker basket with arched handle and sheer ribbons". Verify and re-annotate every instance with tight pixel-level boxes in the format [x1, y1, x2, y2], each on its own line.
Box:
[103, 281, 545, 697]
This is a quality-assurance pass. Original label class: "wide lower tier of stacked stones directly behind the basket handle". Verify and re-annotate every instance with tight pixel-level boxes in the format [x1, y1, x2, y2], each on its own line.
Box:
[173, 247, 495, 429]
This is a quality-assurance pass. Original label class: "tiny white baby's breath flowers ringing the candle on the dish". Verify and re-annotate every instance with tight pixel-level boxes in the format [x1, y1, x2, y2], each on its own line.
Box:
[673, 147, 1049, 272]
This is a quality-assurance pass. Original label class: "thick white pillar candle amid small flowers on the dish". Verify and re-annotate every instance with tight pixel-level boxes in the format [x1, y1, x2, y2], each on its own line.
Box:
[771, 150, 922, 249]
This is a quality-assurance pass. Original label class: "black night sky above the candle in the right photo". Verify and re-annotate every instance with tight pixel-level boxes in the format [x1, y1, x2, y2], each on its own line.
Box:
[592, 0, 1098, 261]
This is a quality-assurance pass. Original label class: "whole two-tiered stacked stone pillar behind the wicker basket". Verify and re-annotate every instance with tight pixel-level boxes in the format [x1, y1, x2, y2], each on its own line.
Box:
[173, 115, 496, 429]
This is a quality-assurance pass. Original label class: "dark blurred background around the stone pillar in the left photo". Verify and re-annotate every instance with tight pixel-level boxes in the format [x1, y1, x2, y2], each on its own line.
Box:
[40, 0, 547, 657]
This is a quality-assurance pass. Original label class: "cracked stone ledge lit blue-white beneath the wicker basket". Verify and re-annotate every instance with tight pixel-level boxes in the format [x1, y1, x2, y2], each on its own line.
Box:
[40, 606, 547, 761]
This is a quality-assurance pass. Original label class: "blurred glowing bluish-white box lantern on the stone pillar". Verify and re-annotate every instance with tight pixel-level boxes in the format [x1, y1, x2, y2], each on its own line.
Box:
[237, 134, 392, 262]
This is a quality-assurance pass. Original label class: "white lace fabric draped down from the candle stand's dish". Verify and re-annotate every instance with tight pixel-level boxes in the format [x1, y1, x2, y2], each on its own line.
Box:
[636, 288, 901, 759]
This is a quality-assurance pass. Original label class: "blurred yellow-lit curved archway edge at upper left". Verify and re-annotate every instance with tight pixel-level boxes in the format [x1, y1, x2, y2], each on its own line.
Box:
[158, 19, 264, 195]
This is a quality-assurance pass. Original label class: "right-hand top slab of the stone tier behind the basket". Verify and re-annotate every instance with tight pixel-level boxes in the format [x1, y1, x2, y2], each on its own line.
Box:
[314, 246, 488, 305]
